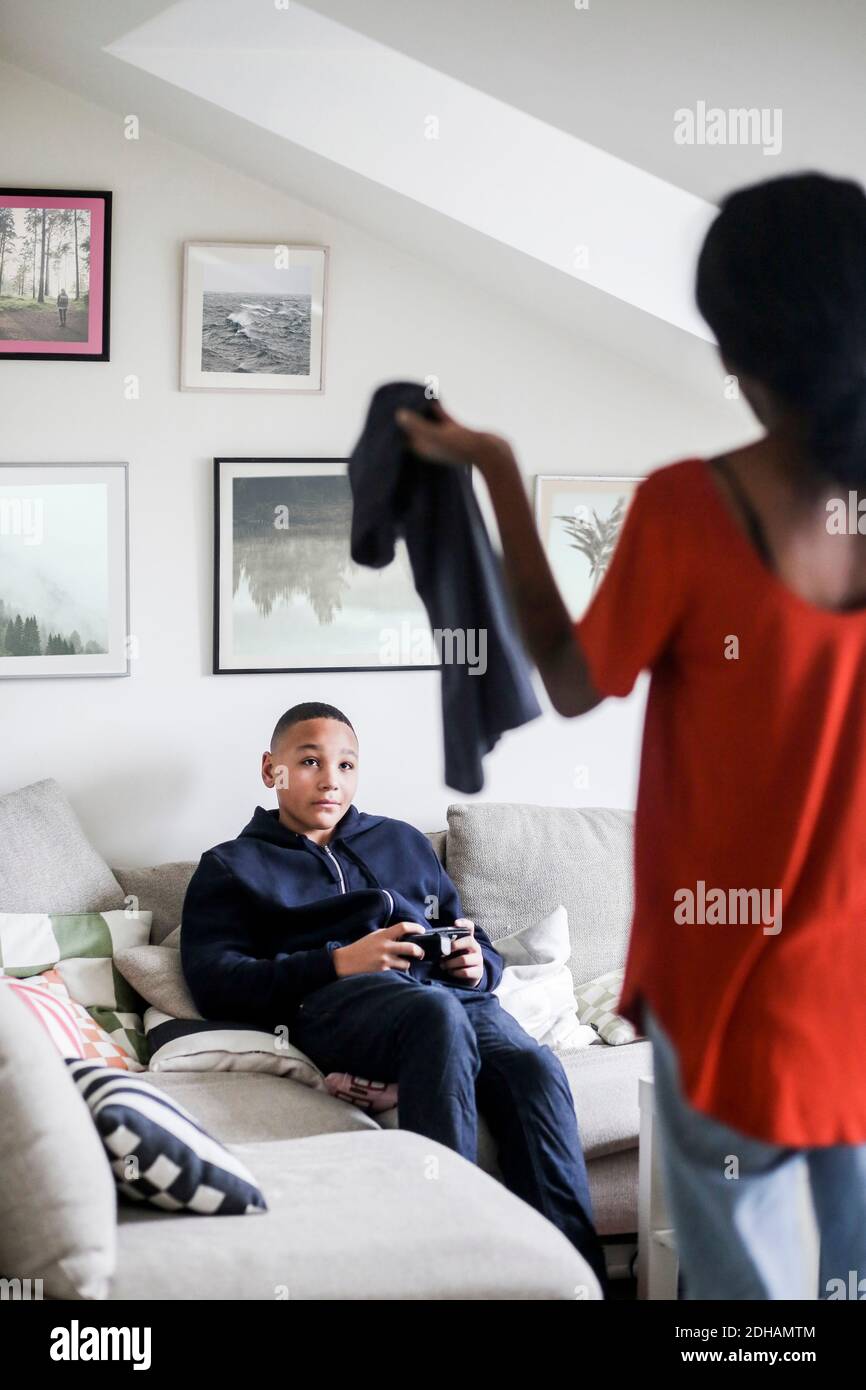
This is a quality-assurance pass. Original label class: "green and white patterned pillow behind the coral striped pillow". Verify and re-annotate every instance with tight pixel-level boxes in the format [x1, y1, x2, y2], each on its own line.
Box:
[0, 908, 152, 1066]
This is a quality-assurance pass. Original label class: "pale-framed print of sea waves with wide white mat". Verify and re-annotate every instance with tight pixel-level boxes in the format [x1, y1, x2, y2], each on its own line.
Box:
[181, 242, 328, 392]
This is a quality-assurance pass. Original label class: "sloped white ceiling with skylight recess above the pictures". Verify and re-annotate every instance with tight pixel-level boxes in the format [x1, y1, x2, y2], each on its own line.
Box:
[0, 0, 866, 392]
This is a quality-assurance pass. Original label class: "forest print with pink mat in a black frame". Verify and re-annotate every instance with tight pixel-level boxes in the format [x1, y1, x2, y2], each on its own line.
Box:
[0, 188, 111, 361]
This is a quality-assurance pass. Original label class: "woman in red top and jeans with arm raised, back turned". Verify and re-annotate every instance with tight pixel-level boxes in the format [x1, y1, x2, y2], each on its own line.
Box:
[400, 174, 866, 1298]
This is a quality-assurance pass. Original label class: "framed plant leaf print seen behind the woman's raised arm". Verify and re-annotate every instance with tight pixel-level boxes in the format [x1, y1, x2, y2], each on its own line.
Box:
[535, 474, 642, 623]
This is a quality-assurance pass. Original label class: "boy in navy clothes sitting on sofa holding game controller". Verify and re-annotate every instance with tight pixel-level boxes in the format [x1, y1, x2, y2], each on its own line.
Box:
[181, 702, 607, 1290]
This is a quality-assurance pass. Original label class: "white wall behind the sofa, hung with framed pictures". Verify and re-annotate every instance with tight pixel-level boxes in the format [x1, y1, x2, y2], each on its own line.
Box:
[0, 67, 751, 865]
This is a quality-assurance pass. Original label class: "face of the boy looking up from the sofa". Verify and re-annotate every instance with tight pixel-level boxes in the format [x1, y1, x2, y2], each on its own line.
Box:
[261, 719, 359, 844]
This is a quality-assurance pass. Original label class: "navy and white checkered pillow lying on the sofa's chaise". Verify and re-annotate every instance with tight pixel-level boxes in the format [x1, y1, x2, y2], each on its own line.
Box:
[65, 1058, 268, 1216]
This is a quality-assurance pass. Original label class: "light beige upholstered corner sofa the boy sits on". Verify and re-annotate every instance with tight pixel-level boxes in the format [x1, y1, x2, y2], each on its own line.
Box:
[0, 778, 651, 1300]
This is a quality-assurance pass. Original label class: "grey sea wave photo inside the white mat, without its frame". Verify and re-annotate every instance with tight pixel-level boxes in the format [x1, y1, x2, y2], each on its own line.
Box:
[202, 291, 313, 377]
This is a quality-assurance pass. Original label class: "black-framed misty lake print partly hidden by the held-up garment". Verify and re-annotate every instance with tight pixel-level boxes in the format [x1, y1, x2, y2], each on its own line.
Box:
[214, 459, 439, 674]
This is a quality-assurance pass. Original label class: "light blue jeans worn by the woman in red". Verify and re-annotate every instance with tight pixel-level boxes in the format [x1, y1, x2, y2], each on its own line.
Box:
[644, 1001, 866, 1300]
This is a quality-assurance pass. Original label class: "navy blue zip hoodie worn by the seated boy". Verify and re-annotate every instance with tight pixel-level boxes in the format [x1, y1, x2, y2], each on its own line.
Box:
[181, 805, 505, 1030]
